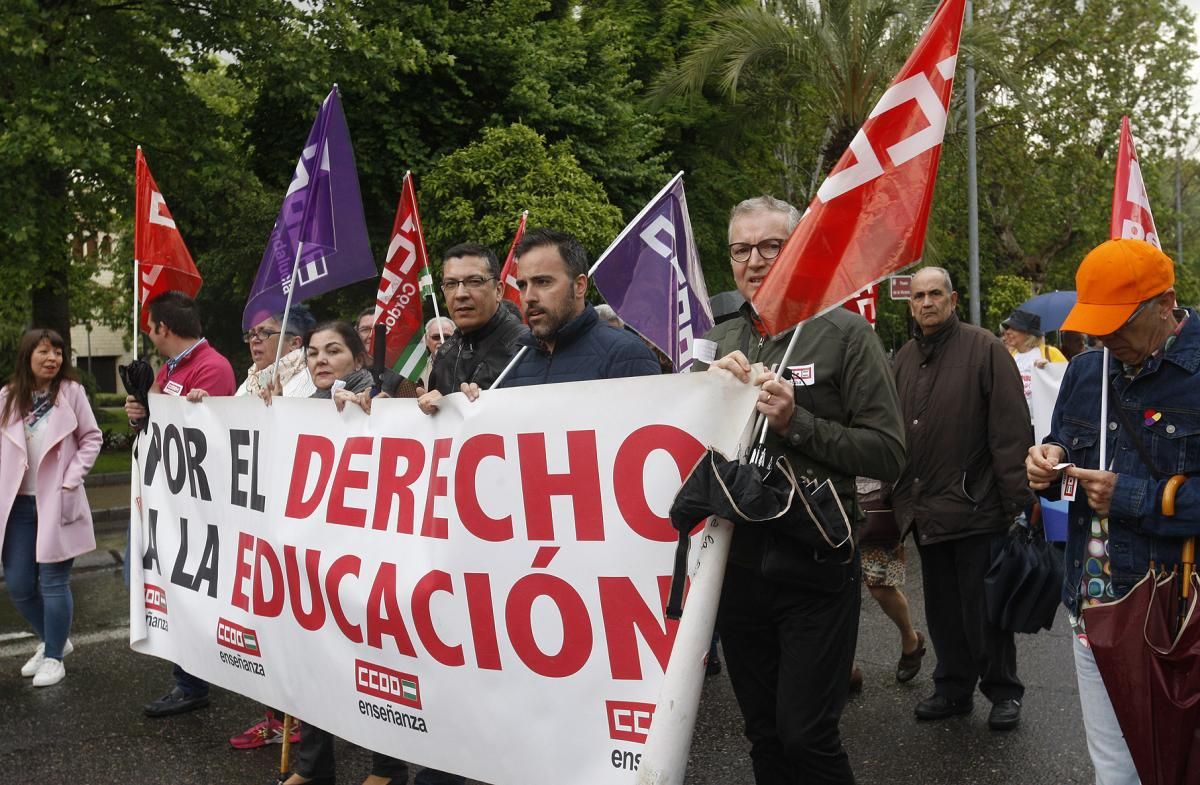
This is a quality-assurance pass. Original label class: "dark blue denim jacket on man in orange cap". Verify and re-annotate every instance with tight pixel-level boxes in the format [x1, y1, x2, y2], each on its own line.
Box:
[1043, 308, 1200, 613]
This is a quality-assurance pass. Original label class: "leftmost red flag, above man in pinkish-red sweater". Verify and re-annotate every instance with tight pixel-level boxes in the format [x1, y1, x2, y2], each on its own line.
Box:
[133, 146, 204, 331]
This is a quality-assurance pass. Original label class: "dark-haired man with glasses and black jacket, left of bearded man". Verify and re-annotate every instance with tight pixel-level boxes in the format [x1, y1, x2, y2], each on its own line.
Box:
[418, 242, 526, 414]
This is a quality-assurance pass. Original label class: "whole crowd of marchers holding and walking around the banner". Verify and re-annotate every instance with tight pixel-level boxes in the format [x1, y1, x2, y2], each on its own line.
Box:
[0, 196, 1180, 785]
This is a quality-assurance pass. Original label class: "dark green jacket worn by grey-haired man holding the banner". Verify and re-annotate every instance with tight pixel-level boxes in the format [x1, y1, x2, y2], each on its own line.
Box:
[697, 305, 905, 567]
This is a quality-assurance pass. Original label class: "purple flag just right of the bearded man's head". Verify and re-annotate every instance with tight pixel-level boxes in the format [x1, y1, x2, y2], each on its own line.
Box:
[592, 172, 713, 371]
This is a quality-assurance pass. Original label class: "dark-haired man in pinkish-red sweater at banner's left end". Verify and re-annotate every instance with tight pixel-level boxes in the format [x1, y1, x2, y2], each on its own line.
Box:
[125, 292, 238, 717]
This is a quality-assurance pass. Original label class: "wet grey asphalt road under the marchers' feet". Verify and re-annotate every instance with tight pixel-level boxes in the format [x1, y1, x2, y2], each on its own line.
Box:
[0, 520, 1092, 785]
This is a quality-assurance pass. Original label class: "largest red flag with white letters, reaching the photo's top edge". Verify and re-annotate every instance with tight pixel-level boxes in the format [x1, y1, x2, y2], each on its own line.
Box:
[754, 0, 966, 335]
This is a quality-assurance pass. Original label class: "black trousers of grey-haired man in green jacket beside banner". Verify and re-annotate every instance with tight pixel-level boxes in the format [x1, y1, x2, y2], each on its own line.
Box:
[716, 558, 862, 785]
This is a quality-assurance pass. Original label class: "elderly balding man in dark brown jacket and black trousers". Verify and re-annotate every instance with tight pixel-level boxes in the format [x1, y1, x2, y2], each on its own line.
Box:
[893, 268, 1033, 730]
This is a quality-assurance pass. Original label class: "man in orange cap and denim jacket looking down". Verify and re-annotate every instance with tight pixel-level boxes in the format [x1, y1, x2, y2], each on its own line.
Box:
[1025, 240, 1200, 785]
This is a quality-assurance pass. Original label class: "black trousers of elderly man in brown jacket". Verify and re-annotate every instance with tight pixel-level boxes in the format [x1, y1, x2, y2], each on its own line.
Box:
[917, 533, 1025, 703]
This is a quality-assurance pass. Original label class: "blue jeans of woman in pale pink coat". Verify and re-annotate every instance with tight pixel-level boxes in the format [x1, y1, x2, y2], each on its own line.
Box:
[0, 496, 74, 660]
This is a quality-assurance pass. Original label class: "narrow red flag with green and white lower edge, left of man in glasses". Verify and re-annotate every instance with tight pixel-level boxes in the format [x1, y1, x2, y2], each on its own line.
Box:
[376, 172, 433, 379]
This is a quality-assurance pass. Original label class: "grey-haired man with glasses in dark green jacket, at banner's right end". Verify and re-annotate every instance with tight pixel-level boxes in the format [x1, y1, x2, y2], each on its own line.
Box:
[698, 196, 904, 785]
